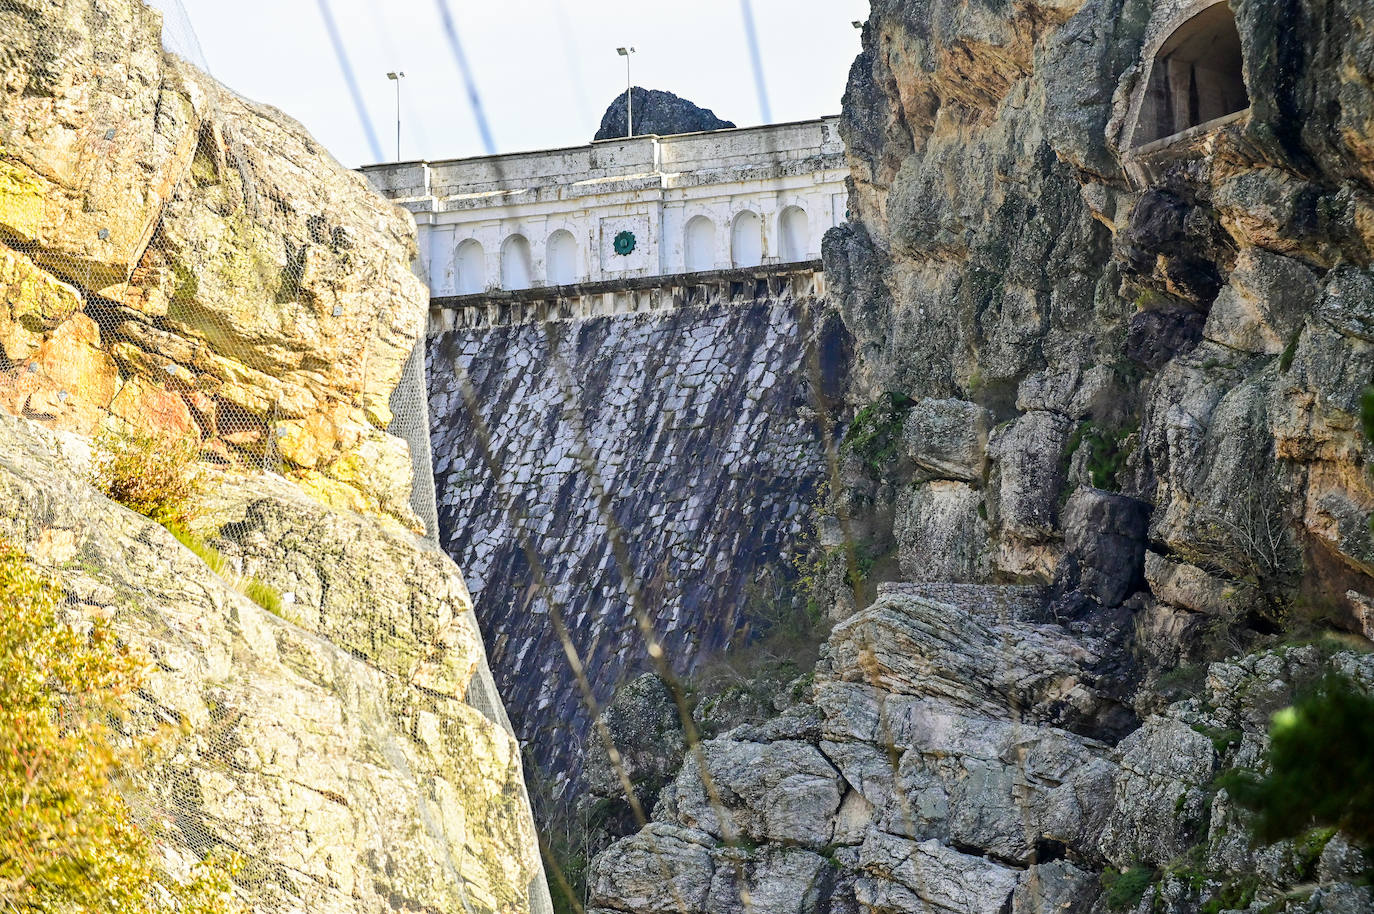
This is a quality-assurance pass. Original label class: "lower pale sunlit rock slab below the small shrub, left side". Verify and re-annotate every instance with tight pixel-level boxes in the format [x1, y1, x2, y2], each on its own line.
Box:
[0, 414, 541, 913]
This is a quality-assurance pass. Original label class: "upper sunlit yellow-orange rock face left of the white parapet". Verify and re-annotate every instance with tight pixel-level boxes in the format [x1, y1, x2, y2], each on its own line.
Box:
[0, 0, 426, 526]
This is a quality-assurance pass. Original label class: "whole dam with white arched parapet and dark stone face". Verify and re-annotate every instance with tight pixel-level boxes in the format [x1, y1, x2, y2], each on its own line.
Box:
[365, 118, 848, 781]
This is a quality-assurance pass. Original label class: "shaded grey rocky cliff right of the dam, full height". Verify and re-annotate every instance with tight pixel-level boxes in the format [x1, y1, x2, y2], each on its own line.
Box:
[589, 0, 1374, 914]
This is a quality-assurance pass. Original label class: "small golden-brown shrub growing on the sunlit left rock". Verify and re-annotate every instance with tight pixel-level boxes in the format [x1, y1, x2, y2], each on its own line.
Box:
[92, 432, 199, 526]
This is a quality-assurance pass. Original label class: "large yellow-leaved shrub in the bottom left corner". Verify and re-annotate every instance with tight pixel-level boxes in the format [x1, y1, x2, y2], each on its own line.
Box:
[0, 542, 240, 914]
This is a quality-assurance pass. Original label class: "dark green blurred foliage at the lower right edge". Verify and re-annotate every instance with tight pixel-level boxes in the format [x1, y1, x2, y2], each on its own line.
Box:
[1223, 676, 1374, 845]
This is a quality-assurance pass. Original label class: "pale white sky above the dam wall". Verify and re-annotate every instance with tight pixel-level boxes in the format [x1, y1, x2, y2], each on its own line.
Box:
[166, 0, 868, 166]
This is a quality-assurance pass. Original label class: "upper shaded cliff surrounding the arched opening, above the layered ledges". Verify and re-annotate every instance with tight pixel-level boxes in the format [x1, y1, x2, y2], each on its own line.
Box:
[827, 0, 1374, 634]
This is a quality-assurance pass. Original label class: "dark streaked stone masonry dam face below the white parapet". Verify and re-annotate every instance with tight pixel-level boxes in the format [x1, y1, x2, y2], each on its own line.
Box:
[427, 296, 842, 778]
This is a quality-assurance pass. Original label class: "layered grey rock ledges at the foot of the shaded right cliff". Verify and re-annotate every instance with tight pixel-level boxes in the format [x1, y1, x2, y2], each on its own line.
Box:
[589, 586, 1374, 914]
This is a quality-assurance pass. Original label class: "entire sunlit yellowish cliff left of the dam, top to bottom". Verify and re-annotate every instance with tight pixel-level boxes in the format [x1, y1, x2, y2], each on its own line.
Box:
[0, 0, 543, 913]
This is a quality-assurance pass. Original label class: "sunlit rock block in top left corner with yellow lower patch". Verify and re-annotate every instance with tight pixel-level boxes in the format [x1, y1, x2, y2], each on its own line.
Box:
[0, 0, 199, 292]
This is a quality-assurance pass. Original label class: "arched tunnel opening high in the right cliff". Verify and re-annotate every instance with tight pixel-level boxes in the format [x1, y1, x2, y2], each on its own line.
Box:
[1134, 0, 1250, 147]
